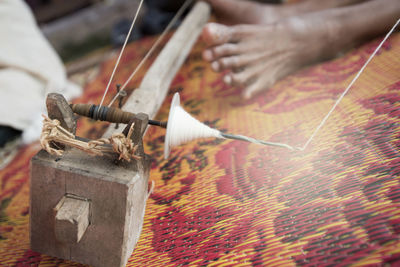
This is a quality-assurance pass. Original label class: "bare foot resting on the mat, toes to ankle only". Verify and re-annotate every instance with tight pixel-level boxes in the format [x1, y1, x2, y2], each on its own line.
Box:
[203, 18, 336, 99]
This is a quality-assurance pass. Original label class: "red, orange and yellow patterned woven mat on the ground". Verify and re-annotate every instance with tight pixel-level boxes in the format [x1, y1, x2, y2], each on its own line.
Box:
[0, 33, 400, 266]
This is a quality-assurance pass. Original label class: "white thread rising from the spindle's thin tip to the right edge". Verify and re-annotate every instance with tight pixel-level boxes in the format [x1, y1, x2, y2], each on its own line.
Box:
[297, 19, 400, 151]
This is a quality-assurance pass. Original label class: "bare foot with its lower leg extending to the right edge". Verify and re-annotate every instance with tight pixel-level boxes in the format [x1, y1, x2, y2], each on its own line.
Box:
[202, 0, 400, 99]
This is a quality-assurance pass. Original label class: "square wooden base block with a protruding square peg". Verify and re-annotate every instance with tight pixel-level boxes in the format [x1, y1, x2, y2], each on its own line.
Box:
[30, 149, 149, 267]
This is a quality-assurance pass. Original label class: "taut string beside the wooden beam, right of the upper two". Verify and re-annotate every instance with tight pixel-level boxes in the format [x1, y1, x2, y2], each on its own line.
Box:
[108, 0, 193, 107]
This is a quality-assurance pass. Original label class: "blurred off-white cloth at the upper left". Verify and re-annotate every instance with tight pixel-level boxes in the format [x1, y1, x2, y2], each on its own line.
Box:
[0, 0, 81, 143]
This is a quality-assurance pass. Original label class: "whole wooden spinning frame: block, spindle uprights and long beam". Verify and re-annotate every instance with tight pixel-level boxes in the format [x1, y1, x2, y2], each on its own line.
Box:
[30, 2, 210, 267]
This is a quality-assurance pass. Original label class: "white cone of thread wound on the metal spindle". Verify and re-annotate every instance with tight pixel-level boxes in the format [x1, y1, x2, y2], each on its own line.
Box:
[164, 93, 223, 159]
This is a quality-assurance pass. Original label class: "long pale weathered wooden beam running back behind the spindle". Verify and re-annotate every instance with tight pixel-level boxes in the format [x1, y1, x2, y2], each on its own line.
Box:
[103, 1, 211, 137]
